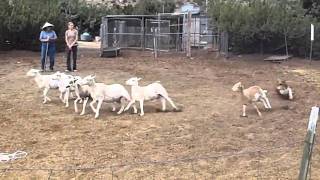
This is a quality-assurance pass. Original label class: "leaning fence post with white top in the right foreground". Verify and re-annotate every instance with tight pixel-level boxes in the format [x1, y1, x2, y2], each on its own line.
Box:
[299, 107, 319, 180]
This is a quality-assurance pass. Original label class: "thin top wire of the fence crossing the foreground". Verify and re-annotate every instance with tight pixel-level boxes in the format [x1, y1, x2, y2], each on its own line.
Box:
[0, 142, 303, 174]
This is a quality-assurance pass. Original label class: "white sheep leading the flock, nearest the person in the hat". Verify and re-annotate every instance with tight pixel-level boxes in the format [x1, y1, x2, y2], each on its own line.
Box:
[27, 69, 60, 103]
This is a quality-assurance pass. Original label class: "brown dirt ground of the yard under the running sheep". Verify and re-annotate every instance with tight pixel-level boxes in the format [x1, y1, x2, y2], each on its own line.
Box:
[0, 45, 320, 179]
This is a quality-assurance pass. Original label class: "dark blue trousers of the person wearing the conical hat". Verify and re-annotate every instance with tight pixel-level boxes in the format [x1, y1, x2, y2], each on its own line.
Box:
[41, 42, 56, 70]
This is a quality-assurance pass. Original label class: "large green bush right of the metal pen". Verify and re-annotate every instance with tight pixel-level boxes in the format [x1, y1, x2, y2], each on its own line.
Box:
[209, 0, 320, 55]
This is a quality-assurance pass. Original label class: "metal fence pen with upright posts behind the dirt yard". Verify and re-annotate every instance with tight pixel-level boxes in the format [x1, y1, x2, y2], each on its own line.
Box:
[101, 14, 228, 57]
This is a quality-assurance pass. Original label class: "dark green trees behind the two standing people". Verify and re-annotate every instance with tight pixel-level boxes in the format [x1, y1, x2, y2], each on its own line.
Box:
[0, 0, 111, 49]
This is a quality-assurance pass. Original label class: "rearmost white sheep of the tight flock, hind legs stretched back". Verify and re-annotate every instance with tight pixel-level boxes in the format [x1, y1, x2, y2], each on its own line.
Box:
[125, 77, 178, 116]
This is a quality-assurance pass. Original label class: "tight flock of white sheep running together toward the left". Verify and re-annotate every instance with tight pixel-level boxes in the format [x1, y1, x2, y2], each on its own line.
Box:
[26, 69, 181, 118]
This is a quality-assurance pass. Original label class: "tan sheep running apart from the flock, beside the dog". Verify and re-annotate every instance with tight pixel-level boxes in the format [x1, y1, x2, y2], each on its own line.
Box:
[232, 82, 271, 117]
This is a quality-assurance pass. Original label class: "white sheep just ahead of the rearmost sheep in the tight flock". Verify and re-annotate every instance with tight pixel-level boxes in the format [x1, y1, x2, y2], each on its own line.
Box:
[79, 75, 137, 118]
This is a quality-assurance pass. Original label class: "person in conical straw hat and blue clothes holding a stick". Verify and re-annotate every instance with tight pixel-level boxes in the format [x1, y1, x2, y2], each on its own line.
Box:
[39, 22, 57, 71]
